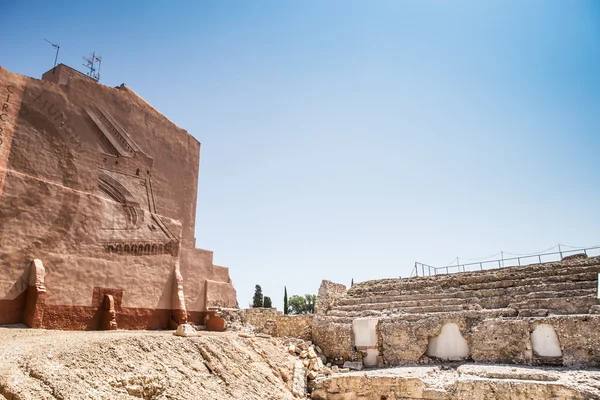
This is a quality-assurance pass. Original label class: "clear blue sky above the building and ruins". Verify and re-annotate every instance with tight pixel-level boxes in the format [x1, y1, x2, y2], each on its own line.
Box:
[0, 0, 600, 307]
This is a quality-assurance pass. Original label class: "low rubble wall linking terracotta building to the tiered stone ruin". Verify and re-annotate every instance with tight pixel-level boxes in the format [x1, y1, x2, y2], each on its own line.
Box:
[240, 308, 313, 340]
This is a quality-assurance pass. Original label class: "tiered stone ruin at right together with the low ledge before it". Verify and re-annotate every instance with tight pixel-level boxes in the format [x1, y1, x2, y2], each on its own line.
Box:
[304, 254, 600, 400]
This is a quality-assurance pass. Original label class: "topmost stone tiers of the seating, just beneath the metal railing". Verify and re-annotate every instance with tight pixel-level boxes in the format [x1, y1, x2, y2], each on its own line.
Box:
[348, 257, 600, 297]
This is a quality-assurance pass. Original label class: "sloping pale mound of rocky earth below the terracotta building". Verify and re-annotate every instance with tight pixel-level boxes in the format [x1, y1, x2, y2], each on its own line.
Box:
[0, 327, 297, 400]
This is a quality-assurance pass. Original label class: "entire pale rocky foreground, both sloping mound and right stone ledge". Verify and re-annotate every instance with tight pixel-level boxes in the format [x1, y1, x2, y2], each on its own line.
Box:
[0, 327, 600, 400]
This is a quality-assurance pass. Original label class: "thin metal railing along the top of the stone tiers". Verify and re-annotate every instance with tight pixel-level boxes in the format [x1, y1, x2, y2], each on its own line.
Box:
[410, 246, 600, 278]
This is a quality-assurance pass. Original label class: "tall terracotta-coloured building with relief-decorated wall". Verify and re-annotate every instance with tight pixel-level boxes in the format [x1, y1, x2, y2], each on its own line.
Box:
[0, 64, 236, 330]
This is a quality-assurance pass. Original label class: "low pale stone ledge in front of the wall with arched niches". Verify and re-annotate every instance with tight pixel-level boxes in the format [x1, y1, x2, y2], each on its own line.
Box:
[310, 364, 600, 400]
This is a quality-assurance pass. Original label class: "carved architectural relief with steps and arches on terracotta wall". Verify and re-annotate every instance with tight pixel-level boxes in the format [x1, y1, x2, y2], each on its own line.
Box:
[86, 107, 179, 256]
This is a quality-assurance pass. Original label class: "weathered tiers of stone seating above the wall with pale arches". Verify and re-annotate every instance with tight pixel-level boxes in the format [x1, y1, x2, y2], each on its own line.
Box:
[327, 257, 600, 318]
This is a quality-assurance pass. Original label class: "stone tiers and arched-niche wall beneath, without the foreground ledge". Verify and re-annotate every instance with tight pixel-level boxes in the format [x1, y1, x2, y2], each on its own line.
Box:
[312, 255, 600, 368]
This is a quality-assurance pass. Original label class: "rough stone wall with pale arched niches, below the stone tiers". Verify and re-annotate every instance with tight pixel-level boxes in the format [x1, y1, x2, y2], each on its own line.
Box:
[313, 311, 600, 367]
